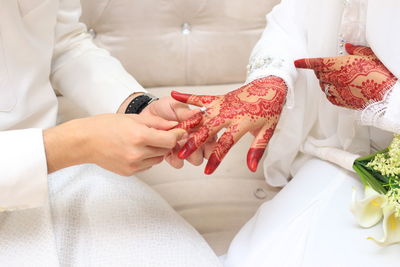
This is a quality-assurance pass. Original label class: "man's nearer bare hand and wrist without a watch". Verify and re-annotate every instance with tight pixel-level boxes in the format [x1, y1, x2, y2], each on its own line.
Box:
[44, 114, 185, 176]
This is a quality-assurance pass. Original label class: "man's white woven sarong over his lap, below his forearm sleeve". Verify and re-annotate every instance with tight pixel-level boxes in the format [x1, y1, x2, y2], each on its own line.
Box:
[0, 165, 221, 267]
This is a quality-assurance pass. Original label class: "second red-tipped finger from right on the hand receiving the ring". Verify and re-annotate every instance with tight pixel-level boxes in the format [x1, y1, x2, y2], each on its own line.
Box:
[204, 124, 247, 175]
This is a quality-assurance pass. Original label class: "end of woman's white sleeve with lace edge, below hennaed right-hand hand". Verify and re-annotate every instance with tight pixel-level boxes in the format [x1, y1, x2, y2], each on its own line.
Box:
[361, 82, 400, 133]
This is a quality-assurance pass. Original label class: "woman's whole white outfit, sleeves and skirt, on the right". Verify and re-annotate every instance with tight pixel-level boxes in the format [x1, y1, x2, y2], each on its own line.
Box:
[225, 0, 400, 267]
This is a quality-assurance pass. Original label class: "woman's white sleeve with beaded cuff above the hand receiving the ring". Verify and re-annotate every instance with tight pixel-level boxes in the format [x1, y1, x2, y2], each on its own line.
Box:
[246, 0, 307, 107]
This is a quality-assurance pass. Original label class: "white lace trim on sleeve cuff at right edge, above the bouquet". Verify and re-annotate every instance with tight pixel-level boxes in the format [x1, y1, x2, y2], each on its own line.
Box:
[361, 86, 400, 133]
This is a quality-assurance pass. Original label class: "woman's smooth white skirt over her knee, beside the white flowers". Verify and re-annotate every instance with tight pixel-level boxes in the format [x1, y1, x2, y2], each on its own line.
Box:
[224, 159, 400, 267]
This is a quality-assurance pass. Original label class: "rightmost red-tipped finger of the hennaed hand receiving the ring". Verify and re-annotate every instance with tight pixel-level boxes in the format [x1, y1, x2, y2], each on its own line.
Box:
[247, 124, 276, 172]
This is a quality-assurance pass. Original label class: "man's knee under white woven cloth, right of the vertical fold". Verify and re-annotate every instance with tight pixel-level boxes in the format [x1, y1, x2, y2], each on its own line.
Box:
[49, 165, 221, 267]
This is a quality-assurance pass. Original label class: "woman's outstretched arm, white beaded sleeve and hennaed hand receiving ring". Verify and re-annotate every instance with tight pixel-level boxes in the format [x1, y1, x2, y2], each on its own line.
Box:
[173, 0, 306, 174]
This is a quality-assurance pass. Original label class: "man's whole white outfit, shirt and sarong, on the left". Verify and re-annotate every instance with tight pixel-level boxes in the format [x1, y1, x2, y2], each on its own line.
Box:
[0, 0, 220, 267]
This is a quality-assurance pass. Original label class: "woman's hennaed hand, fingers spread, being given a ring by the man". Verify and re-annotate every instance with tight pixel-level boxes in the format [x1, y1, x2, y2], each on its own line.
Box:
[171, 76, 287, 174]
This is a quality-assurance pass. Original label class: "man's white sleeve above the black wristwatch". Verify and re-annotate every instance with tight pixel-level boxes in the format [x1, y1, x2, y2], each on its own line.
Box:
[51, 0, 144, 114]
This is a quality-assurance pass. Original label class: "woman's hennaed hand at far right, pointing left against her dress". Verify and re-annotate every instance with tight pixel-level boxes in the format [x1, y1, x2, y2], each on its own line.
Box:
[295, 44, 397, 109]
